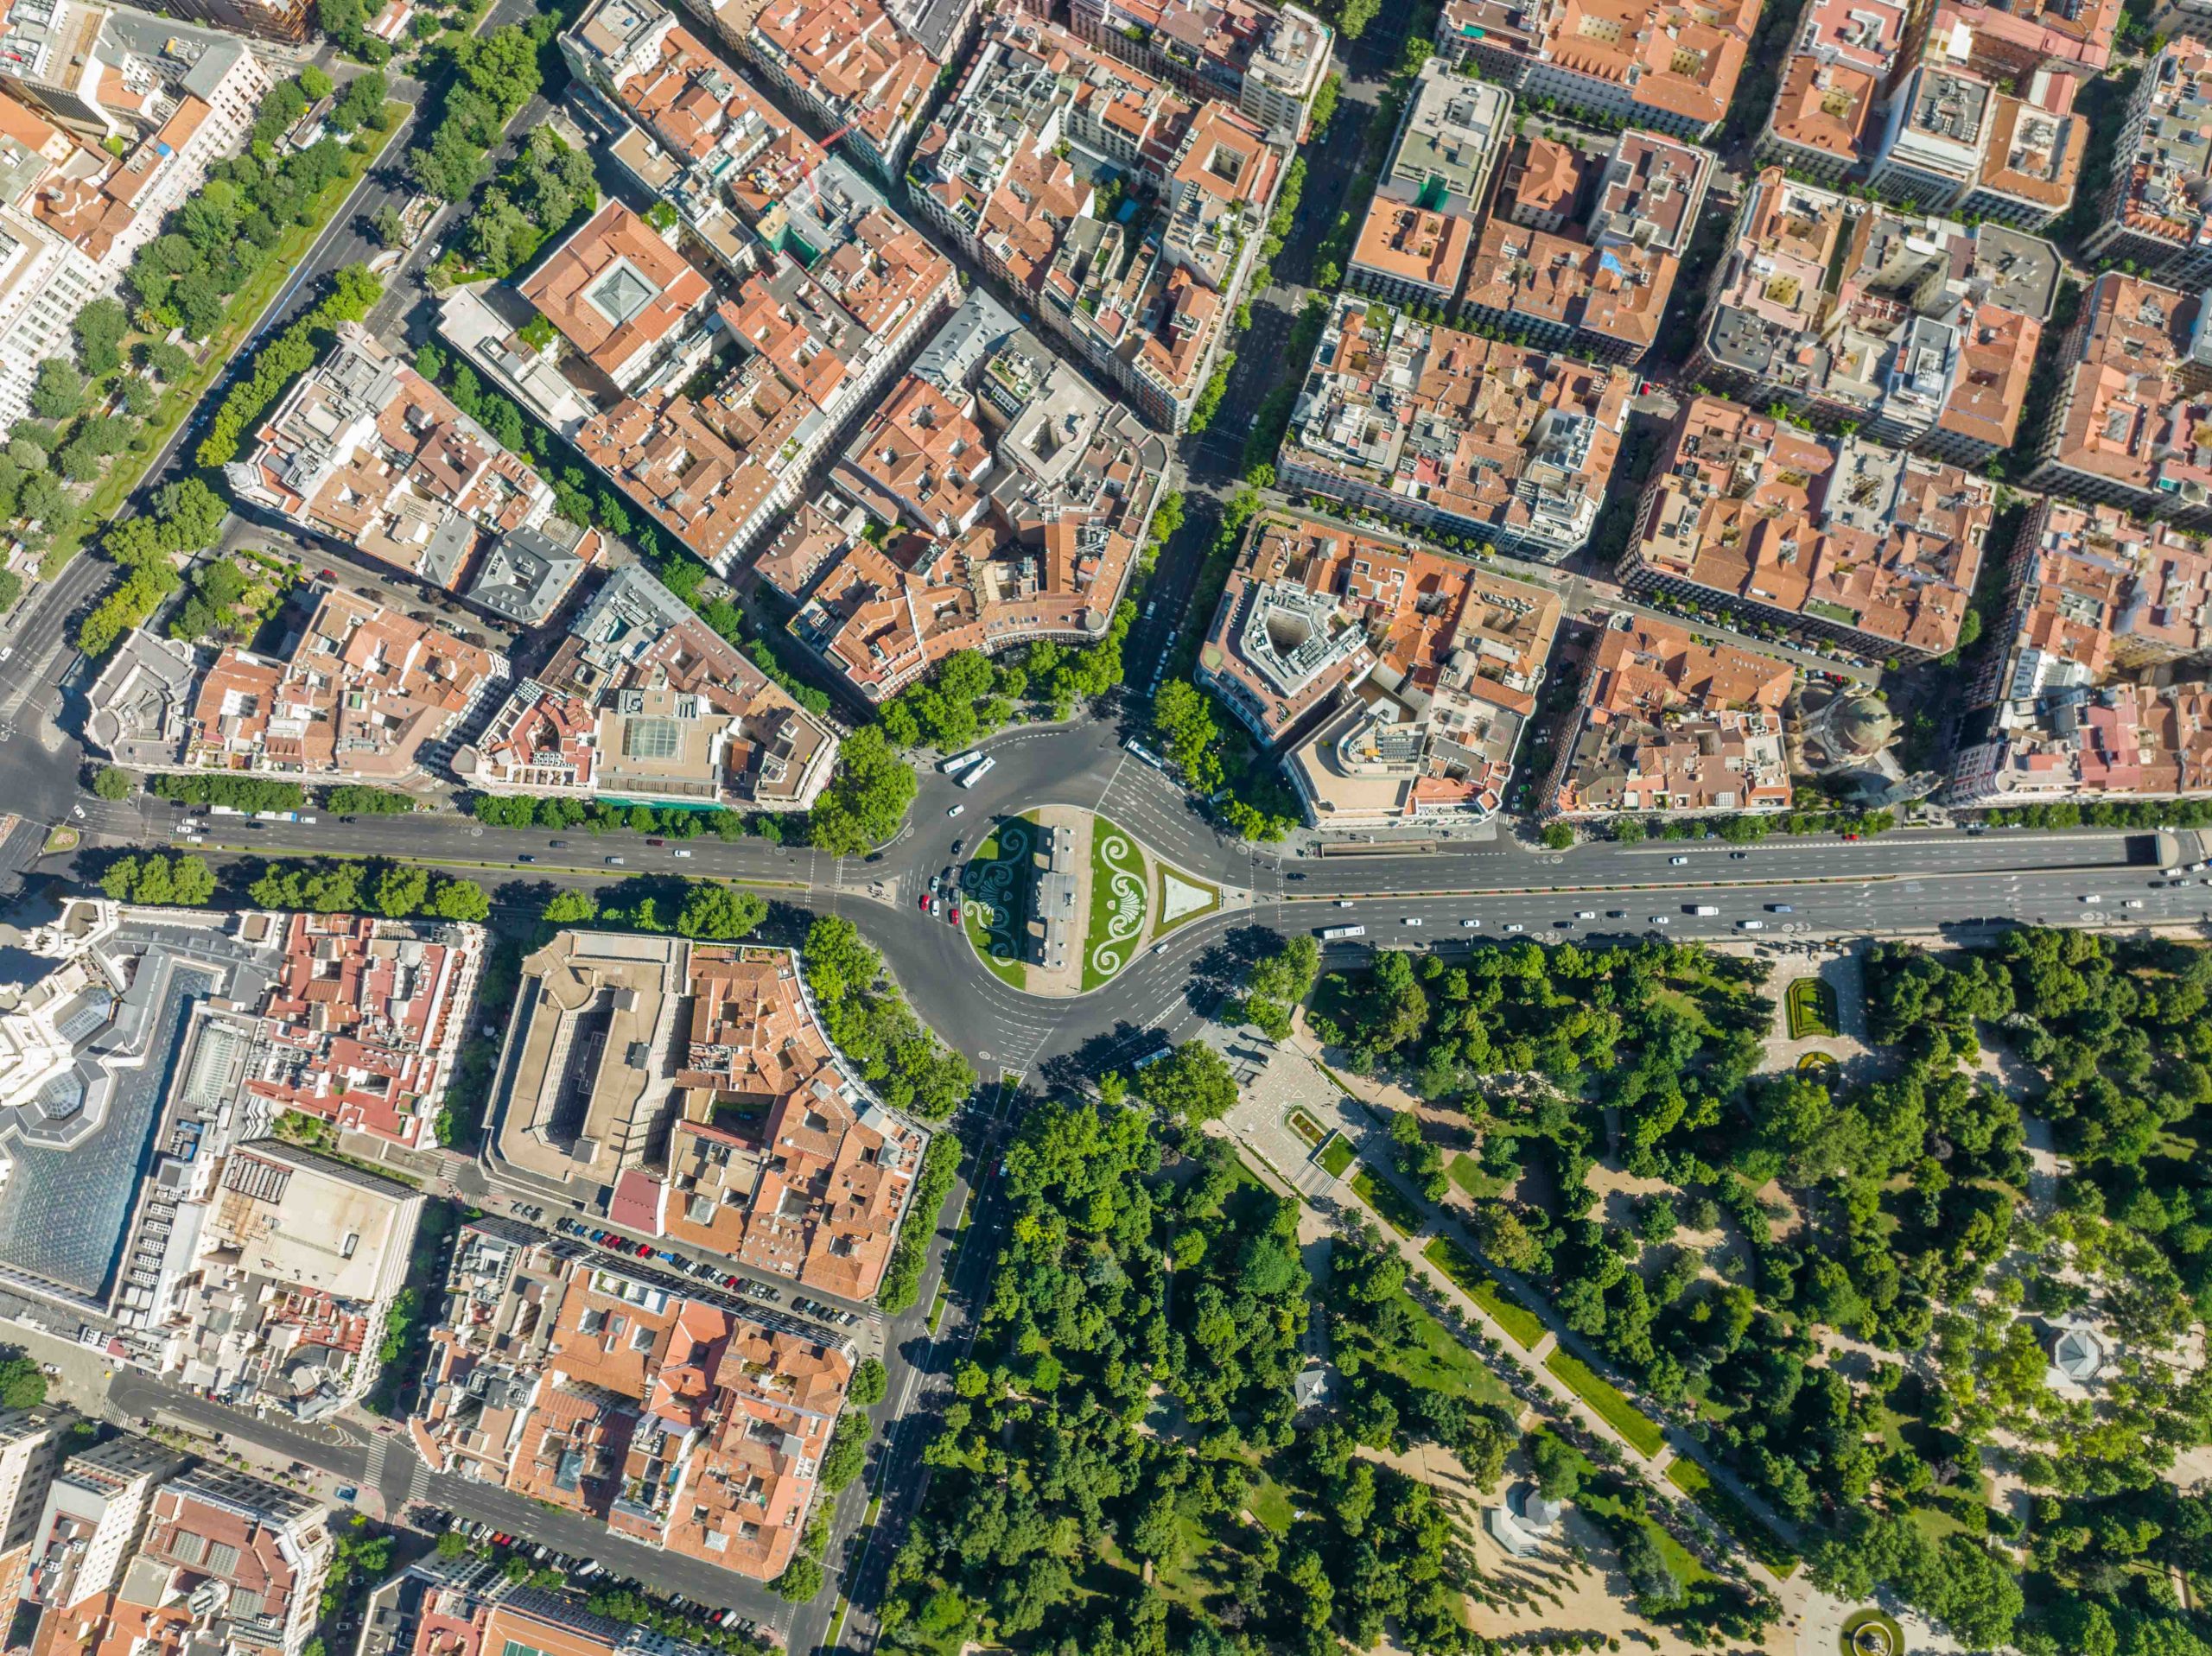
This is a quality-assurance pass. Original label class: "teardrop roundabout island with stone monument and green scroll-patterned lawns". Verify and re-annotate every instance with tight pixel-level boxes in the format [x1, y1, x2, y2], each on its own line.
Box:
[957, 805, 1221, 997]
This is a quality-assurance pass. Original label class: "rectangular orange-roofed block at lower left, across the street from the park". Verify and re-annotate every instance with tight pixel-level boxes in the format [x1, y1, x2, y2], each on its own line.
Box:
[410, 1221, 854, 1581]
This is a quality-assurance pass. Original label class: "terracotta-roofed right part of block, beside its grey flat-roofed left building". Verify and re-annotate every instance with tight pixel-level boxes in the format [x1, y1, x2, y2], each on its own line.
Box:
[1462, 133, 1712, 365]
